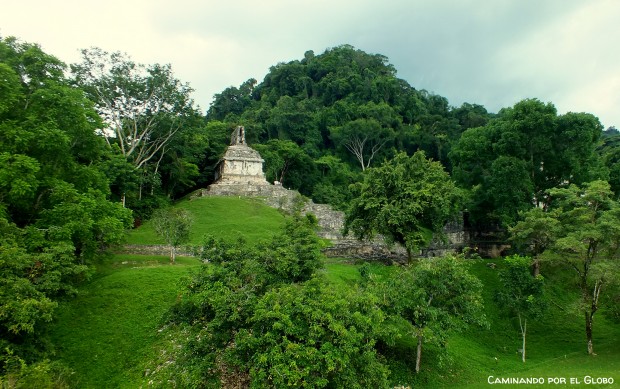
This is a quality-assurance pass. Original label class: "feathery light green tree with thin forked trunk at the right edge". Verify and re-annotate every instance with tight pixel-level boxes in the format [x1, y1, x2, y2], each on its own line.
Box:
[515, 181, 620, 355]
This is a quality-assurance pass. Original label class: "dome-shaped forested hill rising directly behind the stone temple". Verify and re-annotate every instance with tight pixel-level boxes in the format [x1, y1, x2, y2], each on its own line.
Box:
[207, 45, 492, 208]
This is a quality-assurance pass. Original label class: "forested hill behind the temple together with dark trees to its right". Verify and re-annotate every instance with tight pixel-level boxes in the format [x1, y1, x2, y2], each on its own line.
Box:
[206, 45, 617, 233]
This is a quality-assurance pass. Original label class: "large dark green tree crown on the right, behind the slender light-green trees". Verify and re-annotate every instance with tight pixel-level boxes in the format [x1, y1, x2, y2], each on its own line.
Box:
[450, 99, 605, 226]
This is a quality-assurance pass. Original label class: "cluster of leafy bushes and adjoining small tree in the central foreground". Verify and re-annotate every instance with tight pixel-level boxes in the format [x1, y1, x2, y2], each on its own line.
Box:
[162, 212, 485, 388]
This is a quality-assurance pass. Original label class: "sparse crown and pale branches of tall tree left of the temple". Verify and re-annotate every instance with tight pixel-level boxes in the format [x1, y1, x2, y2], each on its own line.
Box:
[71, 48, 199, 171]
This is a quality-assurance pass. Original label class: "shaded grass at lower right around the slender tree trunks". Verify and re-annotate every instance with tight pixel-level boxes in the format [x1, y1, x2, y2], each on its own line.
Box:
[325, 259, 620, 388]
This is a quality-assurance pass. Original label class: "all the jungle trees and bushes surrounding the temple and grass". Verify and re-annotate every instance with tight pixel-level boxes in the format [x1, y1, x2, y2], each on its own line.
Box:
[0, 37, 620, 388]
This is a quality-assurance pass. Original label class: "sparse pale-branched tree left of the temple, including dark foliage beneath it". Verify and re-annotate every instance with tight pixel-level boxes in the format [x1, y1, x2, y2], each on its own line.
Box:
[71, 48, 206, 207]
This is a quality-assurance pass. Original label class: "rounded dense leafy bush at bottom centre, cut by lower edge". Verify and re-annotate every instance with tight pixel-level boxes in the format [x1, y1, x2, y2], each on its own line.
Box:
[238, 279, 388, 388]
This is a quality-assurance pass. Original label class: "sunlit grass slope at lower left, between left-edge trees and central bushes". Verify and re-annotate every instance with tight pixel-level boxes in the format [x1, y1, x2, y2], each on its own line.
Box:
[51, 255, 199, 388]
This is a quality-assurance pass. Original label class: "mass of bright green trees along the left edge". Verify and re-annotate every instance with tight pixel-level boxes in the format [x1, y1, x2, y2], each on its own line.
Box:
[0, 38, 131, 376]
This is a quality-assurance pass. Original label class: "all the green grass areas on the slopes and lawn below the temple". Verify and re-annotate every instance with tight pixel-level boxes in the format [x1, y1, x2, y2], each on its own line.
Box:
[51, 198, 620, 388]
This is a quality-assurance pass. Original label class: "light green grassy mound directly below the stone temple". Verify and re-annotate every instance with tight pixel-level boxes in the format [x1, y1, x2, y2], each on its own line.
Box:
[127, 197, 284, 245]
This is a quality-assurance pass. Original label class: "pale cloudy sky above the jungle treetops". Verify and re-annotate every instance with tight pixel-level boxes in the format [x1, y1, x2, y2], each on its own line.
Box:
[0, 0, 620, 128]
